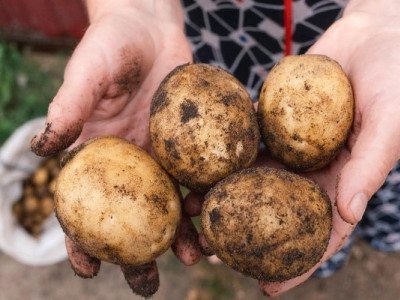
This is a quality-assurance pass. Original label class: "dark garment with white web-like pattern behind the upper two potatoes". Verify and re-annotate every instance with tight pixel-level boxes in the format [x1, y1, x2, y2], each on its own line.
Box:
[182, 0, 347, 100]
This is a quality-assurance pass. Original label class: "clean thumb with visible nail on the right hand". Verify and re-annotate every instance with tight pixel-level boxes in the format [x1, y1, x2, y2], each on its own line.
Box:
[336, 105, 400, 224]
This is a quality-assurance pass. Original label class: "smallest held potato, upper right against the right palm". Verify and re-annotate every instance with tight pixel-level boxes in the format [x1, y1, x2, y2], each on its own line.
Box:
[258, 55, 354, 171]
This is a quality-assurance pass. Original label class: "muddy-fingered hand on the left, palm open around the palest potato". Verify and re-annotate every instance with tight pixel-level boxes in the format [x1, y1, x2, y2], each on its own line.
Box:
[32, 1, 201, 297]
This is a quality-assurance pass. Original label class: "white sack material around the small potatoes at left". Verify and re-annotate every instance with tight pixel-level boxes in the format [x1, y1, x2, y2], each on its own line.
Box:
[0, 118, 67, 266]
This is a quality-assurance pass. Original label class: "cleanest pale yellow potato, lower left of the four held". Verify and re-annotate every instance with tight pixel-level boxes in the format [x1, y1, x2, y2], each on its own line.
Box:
[54, 136, 181, 266]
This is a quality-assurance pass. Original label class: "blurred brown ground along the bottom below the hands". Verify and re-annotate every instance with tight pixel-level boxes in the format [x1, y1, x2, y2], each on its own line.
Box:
[0, 241, 400, 300]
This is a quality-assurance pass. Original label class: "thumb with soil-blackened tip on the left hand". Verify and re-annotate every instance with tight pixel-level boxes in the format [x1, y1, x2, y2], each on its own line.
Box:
[31, 37, 103, 156]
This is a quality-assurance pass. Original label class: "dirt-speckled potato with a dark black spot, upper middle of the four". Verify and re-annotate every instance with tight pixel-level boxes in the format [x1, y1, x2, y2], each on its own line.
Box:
[150, 64, 260, 193]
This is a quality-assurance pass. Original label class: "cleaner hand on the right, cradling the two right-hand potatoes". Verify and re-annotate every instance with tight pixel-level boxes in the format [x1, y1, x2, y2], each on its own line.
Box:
[260, 0, 400, 296]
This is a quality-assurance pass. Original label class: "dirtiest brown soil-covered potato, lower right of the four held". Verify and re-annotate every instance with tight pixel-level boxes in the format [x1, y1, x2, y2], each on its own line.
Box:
[201, 167, 332, 282]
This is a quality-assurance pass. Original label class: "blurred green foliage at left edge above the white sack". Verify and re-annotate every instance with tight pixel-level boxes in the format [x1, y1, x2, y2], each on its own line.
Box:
[0, 37, 61, 145]
